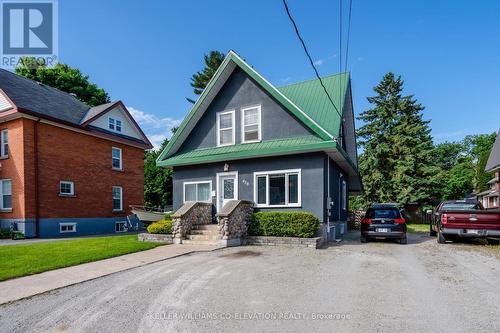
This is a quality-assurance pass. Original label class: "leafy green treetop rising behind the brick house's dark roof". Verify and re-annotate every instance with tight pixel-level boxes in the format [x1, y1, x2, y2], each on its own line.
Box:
[15, 57, 110, 106]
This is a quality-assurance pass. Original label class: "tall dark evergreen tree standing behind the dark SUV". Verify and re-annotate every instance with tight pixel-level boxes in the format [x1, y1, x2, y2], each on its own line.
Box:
[358, 73, 437, 204]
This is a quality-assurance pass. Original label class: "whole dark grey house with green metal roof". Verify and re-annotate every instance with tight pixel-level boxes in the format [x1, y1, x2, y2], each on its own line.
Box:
[157, 51, 361, 239]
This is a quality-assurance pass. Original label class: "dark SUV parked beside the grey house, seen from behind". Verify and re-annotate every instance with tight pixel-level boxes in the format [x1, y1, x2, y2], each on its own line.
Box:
[361, 204, 408, 244]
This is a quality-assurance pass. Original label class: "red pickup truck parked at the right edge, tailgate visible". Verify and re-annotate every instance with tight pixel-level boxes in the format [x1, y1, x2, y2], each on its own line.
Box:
[430, 200, 500, 244]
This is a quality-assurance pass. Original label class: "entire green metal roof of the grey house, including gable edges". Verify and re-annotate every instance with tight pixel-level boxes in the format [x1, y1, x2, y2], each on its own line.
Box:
[156, 51, 354, 167]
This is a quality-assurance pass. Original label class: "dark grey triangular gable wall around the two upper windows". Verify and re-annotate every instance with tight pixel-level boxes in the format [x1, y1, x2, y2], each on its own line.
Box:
[179, 68, 312, 152]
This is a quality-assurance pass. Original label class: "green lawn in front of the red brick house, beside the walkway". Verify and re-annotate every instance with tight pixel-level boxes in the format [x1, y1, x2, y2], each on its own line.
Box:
[0, 235, 162, 281]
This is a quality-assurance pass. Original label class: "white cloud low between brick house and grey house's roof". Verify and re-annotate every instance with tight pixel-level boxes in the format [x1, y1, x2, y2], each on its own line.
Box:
[127, 106, 182, 149]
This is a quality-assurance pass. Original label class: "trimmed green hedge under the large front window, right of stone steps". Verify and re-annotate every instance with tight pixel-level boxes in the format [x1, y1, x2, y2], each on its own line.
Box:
[248, 212, 319, 238]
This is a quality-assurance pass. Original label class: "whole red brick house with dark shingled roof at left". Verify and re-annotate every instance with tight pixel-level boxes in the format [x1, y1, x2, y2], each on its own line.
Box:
[0, 69, 152, 237]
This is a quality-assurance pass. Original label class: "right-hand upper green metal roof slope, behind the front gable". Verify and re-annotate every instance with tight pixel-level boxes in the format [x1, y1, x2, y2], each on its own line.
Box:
[278, 73, 349, 137]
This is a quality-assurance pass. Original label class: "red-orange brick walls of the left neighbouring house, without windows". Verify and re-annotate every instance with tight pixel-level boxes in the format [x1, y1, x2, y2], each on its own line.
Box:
[0, 119, 144, 219]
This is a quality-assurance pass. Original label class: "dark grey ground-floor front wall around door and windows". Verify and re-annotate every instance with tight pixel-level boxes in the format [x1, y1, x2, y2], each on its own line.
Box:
[173, 153, 326, 221]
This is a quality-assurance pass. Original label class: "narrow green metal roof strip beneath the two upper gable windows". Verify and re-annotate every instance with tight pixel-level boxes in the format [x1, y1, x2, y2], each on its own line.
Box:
[157, 135, 337, 167]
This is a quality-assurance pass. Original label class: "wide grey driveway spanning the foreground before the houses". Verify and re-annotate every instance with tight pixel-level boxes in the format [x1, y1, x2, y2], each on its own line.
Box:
[0, 234, 500, 332]
